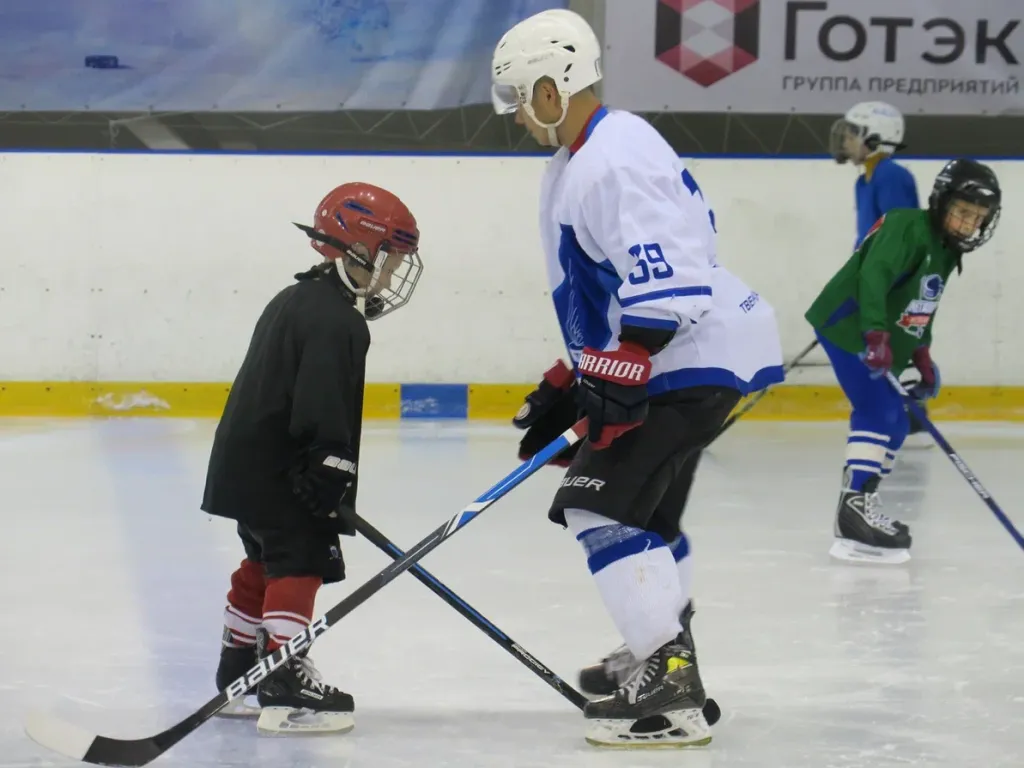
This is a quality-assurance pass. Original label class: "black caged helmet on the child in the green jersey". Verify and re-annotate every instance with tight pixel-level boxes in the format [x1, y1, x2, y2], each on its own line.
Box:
[928, 158, 1002, 253]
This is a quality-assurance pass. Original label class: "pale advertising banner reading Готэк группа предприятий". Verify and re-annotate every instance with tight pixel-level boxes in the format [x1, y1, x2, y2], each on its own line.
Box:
[604, 0, 1024, 115]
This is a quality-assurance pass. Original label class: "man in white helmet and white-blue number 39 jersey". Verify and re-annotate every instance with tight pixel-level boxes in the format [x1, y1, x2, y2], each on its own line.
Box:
[492, 10, 782, 746]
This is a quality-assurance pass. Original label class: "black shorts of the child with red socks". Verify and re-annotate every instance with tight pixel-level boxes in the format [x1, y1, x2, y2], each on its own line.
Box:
[239, 518, 345, 584]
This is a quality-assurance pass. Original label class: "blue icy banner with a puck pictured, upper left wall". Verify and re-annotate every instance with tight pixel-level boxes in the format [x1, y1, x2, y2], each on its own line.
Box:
[0, 0, 568, 112]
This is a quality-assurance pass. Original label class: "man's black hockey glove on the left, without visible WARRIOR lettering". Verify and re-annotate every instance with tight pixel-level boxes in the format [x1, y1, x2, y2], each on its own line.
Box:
[512, 360, 580, 467]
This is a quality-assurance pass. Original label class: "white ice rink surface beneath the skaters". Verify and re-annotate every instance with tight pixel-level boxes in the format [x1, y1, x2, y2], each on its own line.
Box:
[0, 420, 1024, 768]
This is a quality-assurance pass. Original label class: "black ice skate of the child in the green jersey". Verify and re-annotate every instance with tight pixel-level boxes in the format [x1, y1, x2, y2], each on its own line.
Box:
[828, 477, 911, 565]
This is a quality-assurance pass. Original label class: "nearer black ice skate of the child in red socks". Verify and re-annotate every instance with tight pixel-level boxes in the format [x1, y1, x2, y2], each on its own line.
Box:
[256, 630, 355, 735]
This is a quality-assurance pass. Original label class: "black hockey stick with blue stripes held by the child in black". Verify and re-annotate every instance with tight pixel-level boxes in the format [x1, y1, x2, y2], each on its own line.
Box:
[345, 510, 722, 725]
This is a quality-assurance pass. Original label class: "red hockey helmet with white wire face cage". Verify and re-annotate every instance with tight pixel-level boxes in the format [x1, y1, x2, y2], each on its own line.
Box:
[296, 181, 423, 319]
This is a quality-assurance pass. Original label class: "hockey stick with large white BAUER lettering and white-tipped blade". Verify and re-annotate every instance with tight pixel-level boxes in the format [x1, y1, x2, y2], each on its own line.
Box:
[25, 420, 587, 767]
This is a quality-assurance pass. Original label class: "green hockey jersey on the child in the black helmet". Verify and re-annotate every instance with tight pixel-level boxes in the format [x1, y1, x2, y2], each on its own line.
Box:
[804, 209, 959, 376]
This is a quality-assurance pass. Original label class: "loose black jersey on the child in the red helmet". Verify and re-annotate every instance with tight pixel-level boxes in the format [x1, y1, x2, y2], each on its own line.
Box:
[203, 267, 370, 532]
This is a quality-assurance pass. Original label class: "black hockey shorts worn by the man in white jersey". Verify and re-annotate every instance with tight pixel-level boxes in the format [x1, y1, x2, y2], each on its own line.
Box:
[548, 387, 740, 542]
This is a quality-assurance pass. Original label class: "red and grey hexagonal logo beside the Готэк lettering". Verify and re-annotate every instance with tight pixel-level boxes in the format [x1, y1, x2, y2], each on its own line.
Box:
[654, 0, 761, 88]
